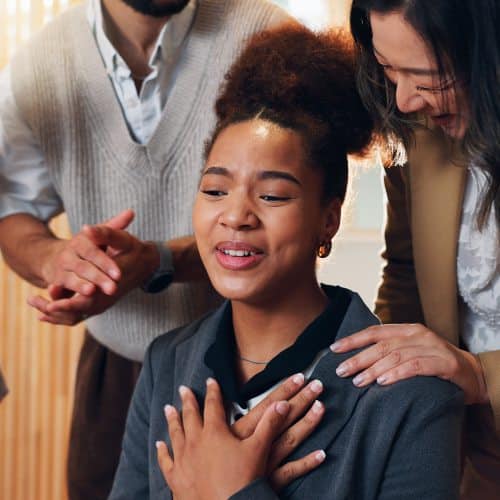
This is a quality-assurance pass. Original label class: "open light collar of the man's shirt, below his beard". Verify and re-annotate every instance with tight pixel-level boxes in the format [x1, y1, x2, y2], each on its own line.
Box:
[87, 0, 197, 75]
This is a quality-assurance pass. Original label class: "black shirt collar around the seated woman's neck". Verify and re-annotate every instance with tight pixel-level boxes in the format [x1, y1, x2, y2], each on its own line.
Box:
[204, 285, 351, 408]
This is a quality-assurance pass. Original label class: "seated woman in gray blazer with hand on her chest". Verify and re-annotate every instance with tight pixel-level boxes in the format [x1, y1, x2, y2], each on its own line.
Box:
[111, 26, 463, 500]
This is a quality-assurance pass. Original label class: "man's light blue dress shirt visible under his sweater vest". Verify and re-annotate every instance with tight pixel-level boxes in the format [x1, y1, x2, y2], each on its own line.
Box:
[0, 0, 196, 221]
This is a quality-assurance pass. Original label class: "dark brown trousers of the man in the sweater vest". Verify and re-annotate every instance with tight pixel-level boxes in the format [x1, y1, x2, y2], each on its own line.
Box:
[67, 332, 141, 500]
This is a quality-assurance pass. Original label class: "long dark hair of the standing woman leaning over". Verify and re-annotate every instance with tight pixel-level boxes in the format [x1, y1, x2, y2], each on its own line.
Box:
[351, 0, 500, 227]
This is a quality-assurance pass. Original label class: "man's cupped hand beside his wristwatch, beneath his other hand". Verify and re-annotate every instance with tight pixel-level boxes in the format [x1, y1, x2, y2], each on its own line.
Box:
[28, 225, 159, 325]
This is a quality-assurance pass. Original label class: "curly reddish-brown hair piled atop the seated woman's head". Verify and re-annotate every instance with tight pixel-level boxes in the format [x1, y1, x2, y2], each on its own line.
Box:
[206, 24, 373, 200]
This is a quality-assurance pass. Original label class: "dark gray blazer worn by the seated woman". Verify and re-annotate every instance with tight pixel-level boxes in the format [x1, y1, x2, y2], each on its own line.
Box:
[110, 292, 463, 500]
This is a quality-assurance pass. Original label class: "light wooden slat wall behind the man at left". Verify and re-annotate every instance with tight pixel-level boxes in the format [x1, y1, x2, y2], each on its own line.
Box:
[0, 0, 349, 500]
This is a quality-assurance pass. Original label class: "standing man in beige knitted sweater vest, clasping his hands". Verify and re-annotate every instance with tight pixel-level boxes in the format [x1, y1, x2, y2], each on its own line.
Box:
[0, 0, 298, 500]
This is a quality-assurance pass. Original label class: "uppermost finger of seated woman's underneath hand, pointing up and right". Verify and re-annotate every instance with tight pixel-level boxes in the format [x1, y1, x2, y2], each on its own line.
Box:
[231, 373, 305, 439]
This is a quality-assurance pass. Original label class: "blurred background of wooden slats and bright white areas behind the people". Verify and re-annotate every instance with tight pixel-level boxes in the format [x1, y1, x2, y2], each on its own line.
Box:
[0, 0, 383, 500]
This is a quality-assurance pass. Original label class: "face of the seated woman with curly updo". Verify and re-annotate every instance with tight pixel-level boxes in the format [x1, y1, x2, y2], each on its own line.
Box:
[193, 119, 340, 304]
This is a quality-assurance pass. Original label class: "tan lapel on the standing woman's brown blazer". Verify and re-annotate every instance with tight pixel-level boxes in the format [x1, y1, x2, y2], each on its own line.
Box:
[409, 131, 467, 344]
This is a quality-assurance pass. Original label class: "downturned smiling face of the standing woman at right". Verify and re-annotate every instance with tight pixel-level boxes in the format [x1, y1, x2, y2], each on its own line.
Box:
[370, 12, 467, 139]
